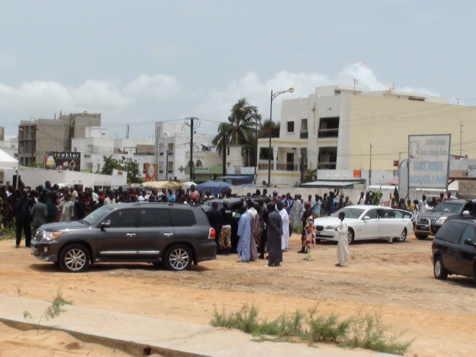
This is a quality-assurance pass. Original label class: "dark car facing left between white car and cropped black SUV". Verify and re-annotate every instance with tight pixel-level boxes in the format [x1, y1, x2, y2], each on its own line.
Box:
[415, 200, 476, 240]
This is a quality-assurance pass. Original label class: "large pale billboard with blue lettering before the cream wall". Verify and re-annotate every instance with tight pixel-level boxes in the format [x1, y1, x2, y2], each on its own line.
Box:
[408, 134, 451, 189]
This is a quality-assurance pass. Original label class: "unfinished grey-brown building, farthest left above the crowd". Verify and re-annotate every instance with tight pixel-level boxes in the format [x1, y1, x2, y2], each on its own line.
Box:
[18, 112, 101, 166]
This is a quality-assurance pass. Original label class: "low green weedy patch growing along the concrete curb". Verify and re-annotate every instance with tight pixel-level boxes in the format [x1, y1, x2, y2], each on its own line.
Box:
[210, 304, 413, 354]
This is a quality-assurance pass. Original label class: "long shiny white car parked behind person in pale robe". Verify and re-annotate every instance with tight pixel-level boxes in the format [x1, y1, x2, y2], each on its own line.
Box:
[314, 206, 413, 243]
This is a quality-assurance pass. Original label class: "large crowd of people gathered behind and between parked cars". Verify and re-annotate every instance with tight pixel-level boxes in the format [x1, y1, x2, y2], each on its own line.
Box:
[0, 181, 453, 267]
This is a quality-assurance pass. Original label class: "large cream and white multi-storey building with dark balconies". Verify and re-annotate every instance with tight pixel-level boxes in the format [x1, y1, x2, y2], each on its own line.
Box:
[257, 86, 476, 186]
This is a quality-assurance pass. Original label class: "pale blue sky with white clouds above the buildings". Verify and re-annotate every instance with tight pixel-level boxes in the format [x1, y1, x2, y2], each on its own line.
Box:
[0, 0, 476, 139]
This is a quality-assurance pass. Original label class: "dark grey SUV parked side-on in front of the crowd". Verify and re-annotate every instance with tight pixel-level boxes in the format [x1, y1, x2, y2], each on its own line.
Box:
[31, 202, 216, 272]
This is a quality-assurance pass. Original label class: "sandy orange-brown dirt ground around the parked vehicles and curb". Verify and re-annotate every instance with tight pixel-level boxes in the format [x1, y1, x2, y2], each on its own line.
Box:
[0, 235, 476, 357]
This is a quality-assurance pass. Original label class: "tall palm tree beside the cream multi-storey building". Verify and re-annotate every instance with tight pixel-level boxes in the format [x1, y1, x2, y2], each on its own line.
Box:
[212, 98, 261, 165]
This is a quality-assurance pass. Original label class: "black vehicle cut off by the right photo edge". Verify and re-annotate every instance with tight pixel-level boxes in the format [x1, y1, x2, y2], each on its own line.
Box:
[432, 220, 476, 283]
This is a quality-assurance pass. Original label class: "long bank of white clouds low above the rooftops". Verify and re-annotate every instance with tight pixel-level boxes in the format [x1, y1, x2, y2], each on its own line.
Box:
[0, 63, 435, 137]
